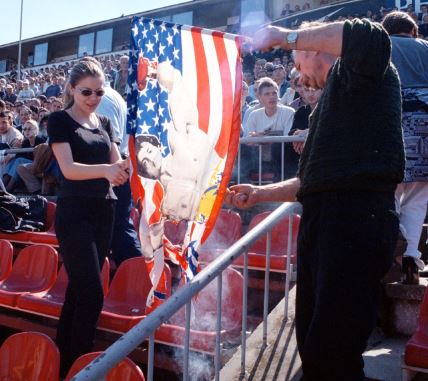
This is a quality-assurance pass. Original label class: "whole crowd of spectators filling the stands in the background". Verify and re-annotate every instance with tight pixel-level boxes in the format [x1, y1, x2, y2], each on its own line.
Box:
[0, 4, 428, 194]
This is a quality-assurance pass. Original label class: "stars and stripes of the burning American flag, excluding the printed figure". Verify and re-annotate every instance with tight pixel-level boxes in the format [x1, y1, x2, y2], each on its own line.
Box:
[127, 17, 242, 310]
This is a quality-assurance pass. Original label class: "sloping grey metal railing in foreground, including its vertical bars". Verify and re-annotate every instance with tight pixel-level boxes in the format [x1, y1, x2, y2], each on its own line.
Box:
[72, 203, 301, 381]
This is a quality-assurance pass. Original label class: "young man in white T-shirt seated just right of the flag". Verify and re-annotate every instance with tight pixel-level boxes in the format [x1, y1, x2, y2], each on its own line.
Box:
[244, 78, 294, 137]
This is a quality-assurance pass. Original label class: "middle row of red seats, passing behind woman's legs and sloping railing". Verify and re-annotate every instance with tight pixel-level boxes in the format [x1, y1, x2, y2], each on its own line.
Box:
[0, 240, 243, 353]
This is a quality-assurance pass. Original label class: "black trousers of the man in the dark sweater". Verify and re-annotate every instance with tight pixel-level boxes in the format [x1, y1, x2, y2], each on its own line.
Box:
[296, 191, 399, 381]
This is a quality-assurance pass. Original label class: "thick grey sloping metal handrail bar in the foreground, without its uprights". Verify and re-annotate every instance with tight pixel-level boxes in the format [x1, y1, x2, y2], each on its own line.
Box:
[71, 203, 301, 381]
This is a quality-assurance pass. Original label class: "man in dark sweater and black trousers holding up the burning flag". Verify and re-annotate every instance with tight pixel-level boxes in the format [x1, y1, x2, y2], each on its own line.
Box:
[226, 19, 404, 381]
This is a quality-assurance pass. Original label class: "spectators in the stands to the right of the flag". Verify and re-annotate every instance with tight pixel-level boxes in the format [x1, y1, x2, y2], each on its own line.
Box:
[240, 0, 428, 182]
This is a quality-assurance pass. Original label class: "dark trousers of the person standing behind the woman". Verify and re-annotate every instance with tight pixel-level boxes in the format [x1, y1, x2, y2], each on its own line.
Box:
[111, 181, 142, 267]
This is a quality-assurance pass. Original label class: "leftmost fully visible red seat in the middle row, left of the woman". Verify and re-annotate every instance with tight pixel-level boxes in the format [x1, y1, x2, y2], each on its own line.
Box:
[0, 245, 58, 307]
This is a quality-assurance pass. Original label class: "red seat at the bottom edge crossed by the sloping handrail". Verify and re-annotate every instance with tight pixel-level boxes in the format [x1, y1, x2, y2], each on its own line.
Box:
[65, 352, 145, 381]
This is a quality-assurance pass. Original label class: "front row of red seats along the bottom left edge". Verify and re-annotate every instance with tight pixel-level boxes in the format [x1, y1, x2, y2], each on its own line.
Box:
[0, 332, 145, 381]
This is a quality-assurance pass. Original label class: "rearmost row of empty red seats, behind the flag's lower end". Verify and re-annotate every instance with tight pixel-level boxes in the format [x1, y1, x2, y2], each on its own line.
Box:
[0, 202, 300, 272]
